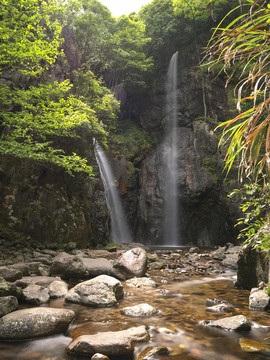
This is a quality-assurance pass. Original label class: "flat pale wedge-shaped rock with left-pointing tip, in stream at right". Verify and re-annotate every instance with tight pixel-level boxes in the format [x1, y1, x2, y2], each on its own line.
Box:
[200, 315, 251, 331]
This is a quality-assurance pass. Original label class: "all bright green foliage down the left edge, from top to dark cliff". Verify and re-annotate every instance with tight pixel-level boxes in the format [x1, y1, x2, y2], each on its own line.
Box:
[0, 0, 118, 176]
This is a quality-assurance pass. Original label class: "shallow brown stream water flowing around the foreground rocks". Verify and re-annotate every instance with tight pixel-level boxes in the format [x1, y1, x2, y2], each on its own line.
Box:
[0, 271, 270, 360]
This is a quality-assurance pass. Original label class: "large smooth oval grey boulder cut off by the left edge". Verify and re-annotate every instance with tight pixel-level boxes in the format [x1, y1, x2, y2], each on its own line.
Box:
[0, 307, 75, 340]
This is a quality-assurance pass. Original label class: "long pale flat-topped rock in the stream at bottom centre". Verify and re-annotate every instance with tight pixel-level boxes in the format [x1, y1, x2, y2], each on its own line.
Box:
[67, 326, 150, 357]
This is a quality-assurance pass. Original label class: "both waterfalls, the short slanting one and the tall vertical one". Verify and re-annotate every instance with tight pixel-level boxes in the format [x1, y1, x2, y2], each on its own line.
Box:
[94, 52, 181, 246]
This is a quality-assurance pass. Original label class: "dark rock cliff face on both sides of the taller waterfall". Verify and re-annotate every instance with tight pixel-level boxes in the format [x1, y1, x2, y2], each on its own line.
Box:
[134, 59, 233, 246]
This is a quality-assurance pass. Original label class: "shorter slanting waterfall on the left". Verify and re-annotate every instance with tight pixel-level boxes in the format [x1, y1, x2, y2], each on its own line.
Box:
[94, 140, 132, 244]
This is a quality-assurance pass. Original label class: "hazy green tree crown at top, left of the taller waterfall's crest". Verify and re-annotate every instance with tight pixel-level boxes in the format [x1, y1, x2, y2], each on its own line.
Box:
[72, 0, 152, 93]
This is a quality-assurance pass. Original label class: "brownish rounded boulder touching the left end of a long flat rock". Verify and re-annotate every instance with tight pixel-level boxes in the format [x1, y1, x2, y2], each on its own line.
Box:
[50, 252, 87, 280]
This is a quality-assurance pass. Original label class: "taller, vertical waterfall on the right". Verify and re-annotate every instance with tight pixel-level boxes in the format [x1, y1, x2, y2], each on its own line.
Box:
[163, 52, 179, 245]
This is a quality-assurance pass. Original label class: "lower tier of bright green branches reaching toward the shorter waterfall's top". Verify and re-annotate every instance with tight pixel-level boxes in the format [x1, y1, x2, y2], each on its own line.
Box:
[0, 81, 104, 174]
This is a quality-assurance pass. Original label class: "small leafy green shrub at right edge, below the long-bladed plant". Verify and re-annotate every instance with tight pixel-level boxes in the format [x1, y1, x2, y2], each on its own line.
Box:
[230, 184, 270, 249]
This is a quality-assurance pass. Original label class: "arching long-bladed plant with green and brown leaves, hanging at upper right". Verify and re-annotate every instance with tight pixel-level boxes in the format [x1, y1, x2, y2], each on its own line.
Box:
[207, 0, 270, 181]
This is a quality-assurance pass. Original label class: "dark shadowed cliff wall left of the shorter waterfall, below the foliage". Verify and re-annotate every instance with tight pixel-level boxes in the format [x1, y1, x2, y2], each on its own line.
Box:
[0, 137, 108, 247]
